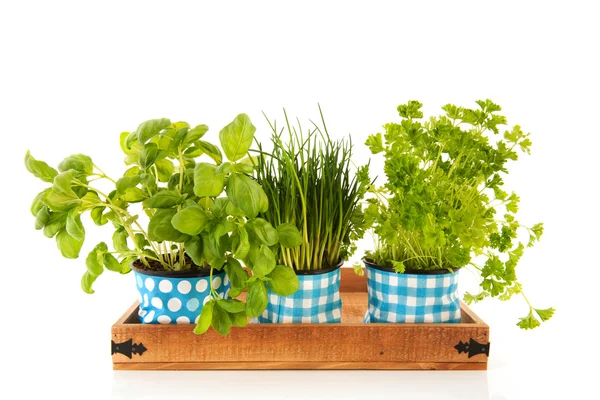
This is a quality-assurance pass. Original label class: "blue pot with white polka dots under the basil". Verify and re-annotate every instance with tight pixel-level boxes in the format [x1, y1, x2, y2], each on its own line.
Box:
[132, 266, 231, 324]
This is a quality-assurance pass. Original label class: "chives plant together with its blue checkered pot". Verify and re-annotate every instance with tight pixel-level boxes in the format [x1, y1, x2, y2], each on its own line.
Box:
[256, 108, 370, 323]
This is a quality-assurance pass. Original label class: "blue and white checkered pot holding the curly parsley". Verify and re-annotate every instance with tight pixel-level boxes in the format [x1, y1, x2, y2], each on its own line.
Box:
[364, 266, 460, 323]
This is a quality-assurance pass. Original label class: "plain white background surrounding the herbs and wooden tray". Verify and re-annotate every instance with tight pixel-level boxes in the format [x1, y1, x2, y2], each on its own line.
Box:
[0, 0, 600, 400]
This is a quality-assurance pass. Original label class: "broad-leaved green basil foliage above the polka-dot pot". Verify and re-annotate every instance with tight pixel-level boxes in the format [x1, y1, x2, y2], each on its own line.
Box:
[25, 114, 300, 335]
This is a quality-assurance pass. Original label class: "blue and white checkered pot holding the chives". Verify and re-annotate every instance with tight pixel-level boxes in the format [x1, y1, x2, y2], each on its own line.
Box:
[254, 268, 342, 324]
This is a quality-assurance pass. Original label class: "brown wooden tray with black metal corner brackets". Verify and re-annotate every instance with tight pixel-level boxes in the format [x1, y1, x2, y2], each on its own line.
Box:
[111, 268, 489, 370]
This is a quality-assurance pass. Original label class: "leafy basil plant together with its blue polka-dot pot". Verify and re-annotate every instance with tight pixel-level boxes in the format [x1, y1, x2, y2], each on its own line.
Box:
[25, 114, 302, 334]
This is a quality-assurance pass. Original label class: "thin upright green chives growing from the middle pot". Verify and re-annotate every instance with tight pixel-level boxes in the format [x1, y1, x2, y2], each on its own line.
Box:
[257, 108, 370, 271]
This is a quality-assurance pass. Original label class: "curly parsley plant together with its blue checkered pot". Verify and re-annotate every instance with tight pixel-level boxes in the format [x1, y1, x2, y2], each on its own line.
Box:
[364, 100, 554, 329]
